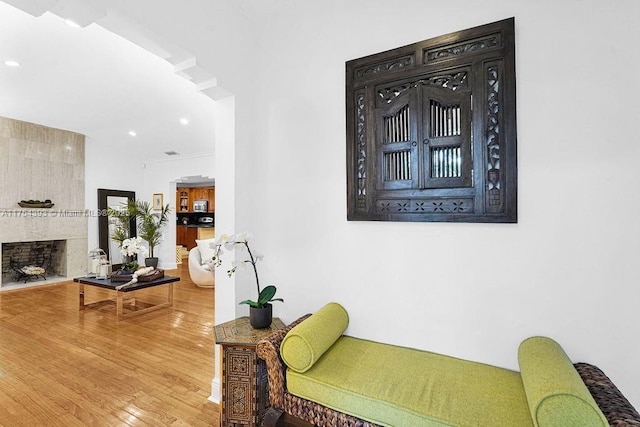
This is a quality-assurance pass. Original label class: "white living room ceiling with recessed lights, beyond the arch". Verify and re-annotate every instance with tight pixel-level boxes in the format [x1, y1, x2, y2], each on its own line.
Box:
[0, 2, 215, 168]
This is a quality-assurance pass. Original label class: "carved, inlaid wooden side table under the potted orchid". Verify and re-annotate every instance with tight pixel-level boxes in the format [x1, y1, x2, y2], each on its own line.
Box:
[215, 317, 285, 427]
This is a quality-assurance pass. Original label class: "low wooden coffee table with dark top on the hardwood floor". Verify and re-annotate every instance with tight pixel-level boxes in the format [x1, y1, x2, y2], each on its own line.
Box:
[73, 276, 180, 320]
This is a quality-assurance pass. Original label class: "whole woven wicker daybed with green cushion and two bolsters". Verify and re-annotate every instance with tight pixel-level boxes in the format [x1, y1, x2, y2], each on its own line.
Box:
[258, 303, 640, 427]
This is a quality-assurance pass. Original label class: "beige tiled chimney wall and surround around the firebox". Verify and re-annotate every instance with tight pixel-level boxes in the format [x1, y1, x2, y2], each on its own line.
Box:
[0, 117, 88, 290]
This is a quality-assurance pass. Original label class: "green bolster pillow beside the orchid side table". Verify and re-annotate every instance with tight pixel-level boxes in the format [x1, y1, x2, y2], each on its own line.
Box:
[280, 302, 349, 372]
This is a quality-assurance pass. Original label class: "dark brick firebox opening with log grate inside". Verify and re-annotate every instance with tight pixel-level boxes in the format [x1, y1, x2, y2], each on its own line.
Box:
[2, 240, 67, 284]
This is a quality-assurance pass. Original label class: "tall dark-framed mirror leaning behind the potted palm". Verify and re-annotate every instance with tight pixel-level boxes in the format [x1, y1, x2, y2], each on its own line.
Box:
[98, 188, 136, 269]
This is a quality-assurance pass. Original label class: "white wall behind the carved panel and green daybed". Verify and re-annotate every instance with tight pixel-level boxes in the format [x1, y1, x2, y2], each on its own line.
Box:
[235, 0, 640, 407]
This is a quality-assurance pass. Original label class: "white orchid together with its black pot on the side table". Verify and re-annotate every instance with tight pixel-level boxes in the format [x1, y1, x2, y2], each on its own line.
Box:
[213, 233, 284, 329]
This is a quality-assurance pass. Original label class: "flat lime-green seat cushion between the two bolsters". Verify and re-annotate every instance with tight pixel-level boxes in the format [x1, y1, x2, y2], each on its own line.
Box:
[287, 336, 533, 427]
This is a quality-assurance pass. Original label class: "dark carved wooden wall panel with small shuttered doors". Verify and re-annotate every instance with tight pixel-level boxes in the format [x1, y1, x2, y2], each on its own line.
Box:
[346, 18, 517, 222]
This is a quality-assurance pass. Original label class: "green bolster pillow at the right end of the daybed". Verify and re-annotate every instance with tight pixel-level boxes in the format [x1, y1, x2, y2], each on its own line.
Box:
[518, 337, 609, 427]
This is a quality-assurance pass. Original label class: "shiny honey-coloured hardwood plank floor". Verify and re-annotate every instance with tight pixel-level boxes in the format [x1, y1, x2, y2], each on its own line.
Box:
[0, 259, 220, 427]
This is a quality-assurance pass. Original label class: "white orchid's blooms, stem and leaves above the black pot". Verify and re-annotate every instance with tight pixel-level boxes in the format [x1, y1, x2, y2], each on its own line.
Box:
[212, 233, 284, 308]
